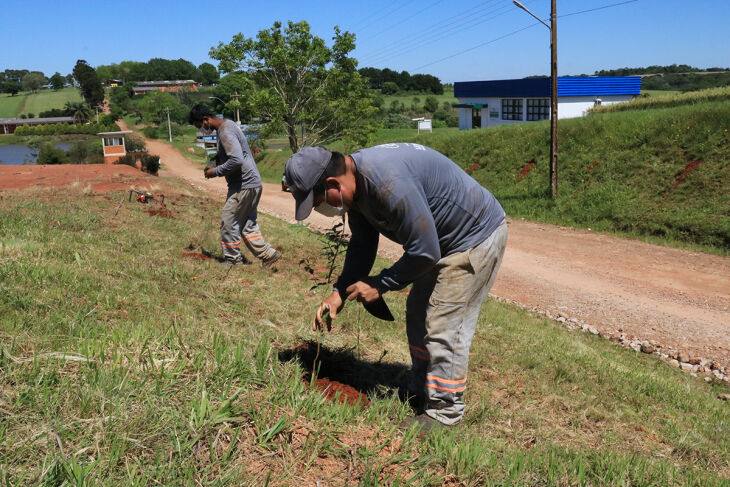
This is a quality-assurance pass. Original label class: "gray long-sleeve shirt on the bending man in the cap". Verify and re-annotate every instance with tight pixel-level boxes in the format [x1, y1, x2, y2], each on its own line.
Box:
[335, 143, 505, 298]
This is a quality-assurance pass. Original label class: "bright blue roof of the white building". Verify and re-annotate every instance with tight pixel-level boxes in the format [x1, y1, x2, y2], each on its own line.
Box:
[454, 76, 641, 98]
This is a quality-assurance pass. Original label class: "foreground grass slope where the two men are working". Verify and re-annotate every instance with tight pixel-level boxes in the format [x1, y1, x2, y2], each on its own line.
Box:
[0, 180, 730, 486]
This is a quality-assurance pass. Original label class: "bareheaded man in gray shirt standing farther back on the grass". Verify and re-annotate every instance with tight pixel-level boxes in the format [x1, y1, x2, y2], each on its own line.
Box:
[189, 103, 281, 267]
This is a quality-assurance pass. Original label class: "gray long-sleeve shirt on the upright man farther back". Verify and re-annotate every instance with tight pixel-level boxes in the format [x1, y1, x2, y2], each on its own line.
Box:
[213, 120, 262, 194]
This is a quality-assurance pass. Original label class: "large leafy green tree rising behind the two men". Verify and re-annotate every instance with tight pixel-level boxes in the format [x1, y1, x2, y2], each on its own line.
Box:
[210, 21, 377, 152]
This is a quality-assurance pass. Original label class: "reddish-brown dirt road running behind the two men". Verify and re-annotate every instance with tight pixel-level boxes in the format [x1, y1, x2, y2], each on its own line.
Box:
[123, 121, 730, 366]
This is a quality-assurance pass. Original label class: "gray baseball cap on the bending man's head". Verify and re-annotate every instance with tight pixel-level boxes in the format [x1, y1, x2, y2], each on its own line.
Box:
[284, 147, 332, 220]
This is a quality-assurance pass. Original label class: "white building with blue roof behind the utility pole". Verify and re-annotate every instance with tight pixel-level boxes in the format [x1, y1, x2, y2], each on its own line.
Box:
[454, 76, 641, 130]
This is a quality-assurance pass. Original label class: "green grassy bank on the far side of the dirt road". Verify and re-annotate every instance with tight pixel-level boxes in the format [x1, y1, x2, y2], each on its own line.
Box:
[253, 89, 730, 255]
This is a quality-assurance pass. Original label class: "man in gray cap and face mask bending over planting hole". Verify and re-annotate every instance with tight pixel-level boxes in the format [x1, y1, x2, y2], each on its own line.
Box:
[285, 143, 507, 429]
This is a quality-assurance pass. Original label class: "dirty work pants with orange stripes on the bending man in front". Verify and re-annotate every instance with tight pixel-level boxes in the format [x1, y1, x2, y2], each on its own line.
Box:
[406, 221, 507, 425]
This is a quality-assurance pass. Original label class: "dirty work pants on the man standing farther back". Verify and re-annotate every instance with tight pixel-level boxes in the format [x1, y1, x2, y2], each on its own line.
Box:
[221, 186, 276, 262]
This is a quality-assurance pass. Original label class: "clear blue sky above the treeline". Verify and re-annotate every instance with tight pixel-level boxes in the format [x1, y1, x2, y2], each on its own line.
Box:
[0, 0, 730, 82]
